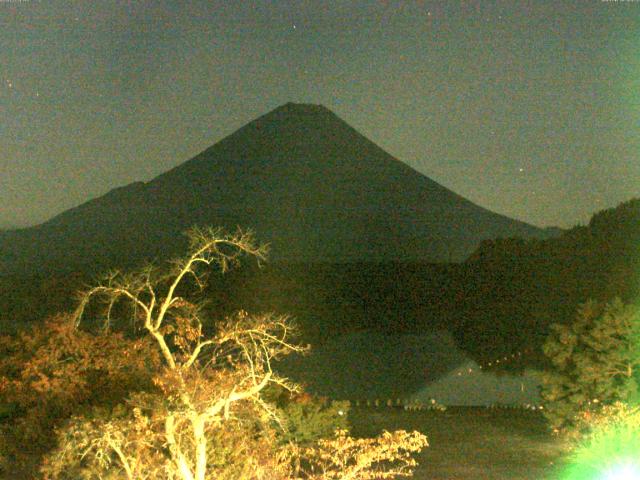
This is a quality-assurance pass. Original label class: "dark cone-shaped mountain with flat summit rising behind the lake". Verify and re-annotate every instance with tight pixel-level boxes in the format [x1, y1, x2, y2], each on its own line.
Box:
[0, 103, 549, 274]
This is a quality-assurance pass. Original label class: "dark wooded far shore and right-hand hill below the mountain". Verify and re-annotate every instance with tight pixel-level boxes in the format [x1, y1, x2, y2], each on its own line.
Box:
[0, 199, 640, 368]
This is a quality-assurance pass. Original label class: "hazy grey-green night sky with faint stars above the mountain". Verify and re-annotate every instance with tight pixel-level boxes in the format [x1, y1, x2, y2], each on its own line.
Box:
[0, 0, 640, 231]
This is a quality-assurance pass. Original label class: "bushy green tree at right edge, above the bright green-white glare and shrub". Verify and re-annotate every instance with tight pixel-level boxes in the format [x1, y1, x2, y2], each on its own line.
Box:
[541, 298, 640, 433]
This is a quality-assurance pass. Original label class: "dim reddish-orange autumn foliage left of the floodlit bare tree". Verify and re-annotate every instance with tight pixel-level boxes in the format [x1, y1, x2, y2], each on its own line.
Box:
[0, 315, 160, 471]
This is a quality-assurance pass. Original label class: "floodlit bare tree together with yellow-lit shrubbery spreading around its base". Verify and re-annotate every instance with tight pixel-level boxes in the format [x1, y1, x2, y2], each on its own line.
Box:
[41, 229, 427, 480]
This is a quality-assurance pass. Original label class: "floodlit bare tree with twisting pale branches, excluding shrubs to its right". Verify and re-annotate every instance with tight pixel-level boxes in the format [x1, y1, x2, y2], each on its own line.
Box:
[49, 229, 303, 480]
